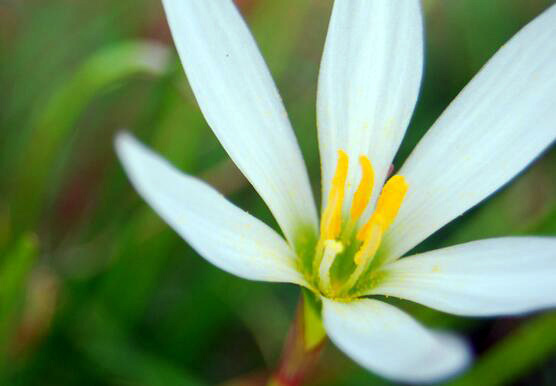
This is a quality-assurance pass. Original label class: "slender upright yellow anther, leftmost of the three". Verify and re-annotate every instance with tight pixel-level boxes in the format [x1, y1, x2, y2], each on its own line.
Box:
[320, 150, 349, 240]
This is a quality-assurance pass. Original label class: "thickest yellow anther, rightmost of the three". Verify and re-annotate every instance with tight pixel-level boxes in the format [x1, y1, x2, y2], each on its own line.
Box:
[357, 176, 409, 241]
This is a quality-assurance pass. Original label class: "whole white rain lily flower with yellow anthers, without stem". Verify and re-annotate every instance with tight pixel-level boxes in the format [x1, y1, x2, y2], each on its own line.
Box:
[116, 0, 556, 382]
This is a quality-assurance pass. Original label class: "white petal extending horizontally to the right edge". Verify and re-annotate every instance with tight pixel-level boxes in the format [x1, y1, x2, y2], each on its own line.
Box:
[370, 237, 556, 316]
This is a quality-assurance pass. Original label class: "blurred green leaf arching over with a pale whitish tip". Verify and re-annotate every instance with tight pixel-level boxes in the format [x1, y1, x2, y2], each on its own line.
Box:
[11, 42, 169, 235]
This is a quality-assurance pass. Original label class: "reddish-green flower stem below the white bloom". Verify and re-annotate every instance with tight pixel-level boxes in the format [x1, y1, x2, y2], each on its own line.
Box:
[268, 290, 326, 386]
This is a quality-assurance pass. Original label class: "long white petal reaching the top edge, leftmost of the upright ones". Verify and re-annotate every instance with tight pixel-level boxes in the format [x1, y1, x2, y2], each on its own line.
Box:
[163, 0, 317, 242]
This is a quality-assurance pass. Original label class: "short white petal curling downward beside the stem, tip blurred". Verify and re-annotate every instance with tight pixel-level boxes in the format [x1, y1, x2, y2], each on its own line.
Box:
[323, 299, 470, 383]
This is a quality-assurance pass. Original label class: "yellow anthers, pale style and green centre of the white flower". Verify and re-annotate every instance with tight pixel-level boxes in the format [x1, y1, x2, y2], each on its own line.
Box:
[313, 150, 408, 298]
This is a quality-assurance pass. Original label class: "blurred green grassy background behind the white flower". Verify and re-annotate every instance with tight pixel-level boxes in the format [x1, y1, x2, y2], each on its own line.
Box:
[0, 0, 556, 386]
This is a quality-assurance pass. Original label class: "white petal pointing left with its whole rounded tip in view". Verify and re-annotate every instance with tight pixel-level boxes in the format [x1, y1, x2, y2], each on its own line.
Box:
[116, 134, 305, 285]
